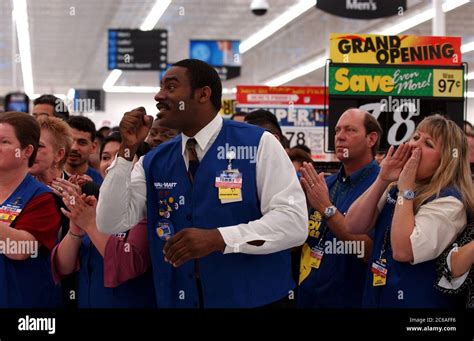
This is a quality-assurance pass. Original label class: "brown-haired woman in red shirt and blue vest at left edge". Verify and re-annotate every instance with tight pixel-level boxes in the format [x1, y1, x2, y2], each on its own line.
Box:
[0, 112, 61, 308]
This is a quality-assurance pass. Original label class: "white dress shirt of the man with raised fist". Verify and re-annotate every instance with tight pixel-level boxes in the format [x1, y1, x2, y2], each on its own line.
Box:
[97, 115, 308, 254]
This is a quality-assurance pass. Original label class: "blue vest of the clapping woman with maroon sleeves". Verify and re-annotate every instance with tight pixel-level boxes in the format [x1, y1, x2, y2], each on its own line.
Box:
[78, 232, 156, 308]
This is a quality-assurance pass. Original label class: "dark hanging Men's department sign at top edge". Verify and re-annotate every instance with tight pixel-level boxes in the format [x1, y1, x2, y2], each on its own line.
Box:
[316, 0, 407, 19]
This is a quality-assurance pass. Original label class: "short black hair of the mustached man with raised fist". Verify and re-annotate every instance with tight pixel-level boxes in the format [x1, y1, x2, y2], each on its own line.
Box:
[173, 59, 222, 111]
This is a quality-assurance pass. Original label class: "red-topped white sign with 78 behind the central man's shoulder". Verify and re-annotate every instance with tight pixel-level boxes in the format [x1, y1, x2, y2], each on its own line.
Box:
[236, 86, 333, 161]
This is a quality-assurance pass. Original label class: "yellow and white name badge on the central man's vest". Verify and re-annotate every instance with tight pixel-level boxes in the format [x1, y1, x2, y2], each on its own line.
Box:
[215, 151, 242, 204]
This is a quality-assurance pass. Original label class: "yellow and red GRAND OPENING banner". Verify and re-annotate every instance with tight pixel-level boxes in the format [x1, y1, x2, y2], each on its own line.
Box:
[329, 33, 462, 66]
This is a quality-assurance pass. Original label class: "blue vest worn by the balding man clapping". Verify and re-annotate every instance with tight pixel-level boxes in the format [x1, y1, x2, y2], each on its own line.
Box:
[298, 161, 380, 308]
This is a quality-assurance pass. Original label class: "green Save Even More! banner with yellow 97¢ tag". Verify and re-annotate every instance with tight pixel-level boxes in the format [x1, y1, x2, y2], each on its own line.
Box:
[329, 65, 464, 97]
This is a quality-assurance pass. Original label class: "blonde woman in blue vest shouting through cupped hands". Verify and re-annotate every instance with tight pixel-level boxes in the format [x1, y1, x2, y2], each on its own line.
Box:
[346, 115, 474, 308]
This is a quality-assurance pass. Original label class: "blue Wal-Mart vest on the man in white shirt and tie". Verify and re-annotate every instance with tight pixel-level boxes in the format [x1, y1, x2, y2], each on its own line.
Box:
[144, 121, 295, 308]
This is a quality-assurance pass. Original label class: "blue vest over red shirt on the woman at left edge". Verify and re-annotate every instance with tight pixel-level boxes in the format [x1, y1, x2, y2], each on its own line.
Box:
[0, 174, 61, 308]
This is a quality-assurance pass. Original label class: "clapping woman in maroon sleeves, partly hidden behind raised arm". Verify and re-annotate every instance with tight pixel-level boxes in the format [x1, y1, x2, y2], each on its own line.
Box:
[52, 134, 155, 308]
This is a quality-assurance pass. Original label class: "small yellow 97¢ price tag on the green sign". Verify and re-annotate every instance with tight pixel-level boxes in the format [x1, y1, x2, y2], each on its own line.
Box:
[433, 69, 464, 97]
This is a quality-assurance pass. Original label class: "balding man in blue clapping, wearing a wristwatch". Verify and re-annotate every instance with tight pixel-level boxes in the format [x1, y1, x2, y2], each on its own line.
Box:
[298, 109, 382, 308]
